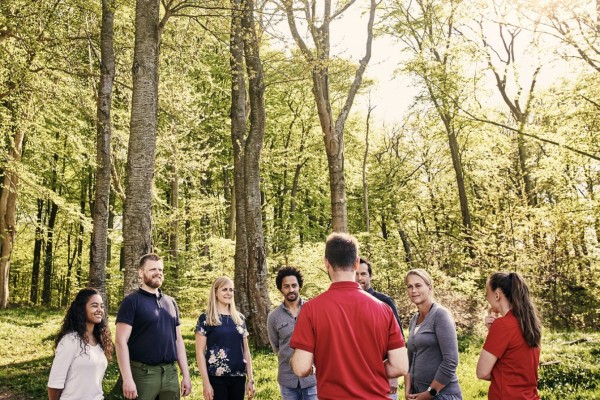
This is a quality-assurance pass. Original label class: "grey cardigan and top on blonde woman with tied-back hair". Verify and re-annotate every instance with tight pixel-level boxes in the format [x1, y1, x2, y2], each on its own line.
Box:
[407, 303, 461, 394]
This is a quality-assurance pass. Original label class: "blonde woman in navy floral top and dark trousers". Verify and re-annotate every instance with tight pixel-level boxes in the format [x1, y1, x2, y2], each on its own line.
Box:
[196, 276, 254, 400]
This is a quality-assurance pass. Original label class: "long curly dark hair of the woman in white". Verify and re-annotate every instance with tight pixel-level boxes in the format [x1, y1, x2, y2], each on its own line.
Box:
[54, 288, 114, 361]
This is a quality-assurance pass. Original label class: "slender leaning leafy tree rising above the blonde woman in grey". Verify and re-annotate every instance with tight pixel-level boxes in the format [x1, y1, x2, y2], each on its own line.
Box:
[388, 0, 475, 257]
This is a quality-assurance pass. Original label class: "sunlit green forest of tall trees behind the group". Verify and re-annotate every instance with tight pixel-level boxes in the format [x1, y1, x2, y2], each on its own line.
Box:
[0, 0, 600, 346]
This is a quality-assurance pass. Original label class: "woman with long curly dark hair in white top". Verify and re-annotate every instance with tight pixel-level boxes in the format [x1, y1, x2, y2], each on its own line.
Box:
[48, 288, 113, 400]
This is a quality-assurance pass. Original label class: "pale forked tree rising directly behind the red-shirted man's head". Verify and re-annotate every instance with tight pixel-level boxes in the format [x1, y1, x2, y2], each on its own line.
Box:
[282, 0, 378, 232]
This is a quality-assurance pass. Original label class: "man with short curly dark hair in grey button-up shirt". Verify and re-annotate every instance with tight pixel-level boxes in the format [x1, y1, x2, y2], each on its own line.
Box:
[267, 267, 317, 400]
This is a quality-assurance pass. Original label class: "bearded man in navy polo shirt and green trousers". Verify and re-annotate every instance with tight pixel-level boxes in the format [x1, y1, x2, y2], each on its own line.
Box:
[115, 253, 192, 400]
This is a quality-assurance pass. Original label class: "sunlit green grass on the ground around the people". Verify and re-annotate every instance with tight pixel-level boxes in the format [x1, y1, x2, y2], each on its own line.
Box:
[0, 308, 600, 400]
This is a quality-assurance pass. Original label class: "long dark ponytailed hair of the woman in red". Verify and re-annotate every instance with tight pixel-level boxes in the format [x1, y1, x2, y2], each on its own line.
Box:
[488, 272, 542, 347]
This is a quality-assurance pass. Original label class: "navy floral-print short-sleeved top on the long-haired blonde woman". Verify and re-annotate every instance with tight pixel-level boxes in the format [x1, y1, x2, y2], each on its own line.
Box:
[196, 313, 248, 376]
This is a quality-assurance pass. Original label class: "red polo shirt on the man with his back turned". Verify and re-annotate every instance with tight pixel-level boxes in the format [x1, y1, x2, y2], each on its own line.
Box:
[290, 281, 404, 400]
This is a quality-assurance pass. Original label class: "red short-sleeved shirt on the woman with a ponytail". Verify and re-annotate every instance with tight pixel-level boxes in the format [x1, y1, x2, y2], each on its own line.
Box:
[483, 310, 540, 400]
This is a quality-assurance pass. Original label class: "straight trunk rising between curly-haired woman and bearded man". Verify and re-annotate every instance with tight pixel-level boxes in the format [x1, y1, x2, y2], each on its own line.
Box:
[89, 0, 115, 304]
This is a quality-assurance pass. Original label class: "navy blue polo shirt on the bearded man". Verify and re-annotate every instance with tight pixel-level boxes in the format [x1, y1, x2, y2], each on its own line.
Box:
[117, 288, 180, 365]
